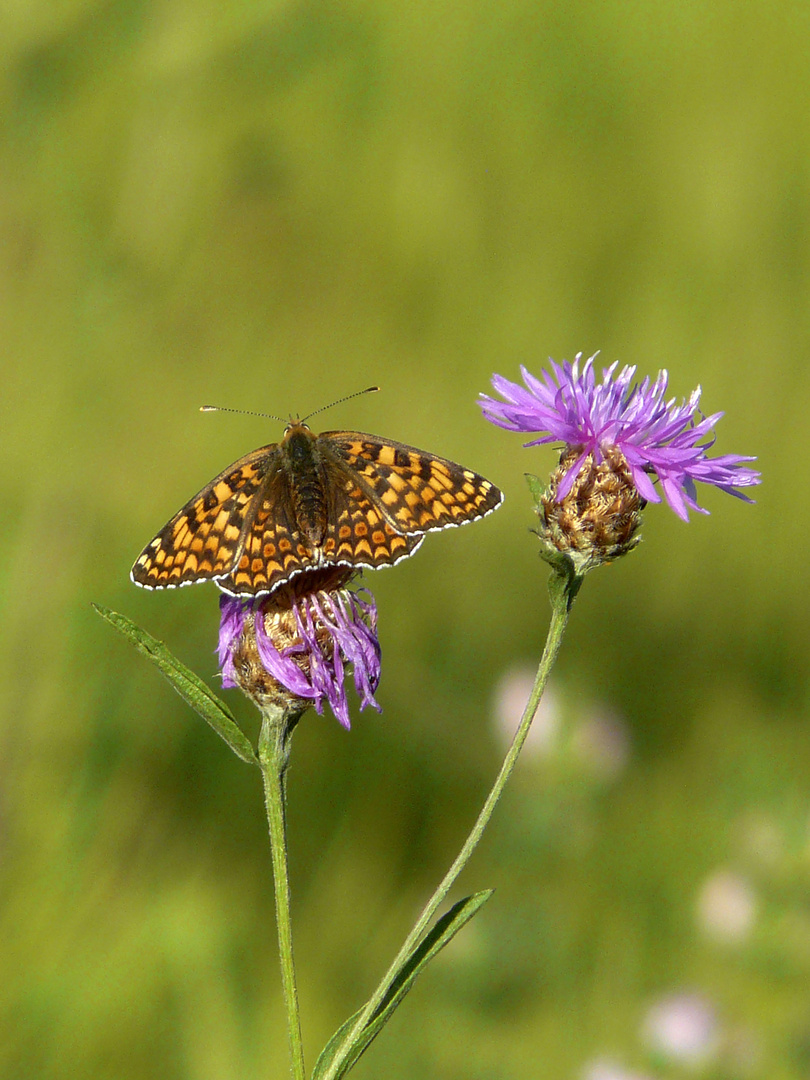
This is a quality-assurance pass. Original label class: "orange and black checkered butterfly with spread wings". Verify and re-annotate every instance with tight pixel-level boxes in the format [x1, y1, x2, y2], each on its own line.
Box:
[131, 419, 503, 597]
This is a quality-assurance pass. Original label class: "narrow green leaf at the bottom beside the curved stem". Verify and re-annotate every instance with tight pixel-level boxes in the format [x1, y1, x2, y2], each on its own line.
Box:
[312, 889, 494, 1080]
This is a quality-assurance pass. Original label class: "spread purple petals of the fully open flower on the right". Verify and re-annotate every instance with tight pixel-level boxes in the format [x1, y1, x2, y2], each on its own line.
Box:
[478, 353, 759, 521]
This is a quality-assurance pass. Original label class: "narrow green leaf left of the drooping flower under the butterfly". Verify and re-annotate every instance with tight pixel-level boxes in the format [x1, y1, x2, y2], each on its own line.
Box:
[92, 604, 258, 765]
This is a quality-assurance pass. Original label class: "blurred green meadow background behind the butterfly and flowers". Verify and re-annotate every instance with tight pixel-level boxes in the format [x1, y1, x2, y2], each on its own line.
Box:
[0, 0, 810, 1080]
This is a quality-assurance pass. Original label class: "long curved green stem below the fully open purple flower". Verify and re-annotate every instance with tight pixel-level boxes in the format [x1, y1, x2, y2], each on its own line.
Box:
[323, 573, 581, 1080]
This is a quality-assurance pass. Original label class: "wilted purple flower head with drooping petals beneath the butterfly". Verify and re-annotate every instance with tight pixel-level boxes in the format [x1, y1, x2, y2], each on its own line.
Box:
[217, 588, 380, 728]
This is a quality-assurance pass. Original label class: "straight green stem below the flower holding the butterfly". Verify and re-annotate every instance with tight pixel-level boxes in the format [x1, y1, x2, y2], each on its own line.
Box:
[259, 710, 306, 1080]
